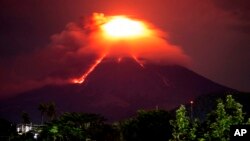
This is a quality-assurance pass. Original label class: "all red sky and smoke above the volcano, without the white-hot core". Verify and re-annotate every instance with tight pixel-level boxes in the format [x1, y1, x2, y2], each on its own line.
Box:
[0, 0, 250, 97]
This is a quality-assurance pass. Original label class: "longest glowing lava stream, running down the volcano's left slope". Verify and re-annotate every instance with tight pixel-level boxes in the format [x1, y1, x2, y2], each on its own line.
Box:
[71, 54, 106, 84]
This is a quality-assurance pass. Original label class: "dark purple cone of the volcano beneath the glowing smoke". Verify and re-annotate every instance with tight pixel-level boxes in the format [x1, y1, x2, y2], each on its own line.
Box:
[0, 58, 232, 122]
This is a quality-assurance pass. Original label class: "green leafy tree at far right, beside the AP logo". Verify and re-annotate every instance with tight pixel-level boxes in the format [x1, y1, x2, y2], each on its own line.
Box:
[204, 95, 247, 141]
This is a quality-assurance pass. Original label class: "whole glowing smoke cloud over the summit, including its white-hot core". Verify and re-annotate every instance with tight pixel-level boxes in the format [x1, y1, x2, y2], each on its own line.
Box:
[0, 13, 190, 96]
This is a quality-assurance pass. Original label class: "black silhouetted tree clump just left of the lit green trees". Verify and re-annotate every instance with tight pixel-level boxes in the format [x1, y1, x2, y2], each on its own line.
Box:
[121, 110, 171, 141]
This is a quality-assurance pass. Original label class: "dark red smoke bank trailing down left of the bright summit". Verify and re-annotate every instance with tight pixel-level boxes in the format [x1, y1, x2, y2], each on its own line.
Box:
[0, 20, 95, 96]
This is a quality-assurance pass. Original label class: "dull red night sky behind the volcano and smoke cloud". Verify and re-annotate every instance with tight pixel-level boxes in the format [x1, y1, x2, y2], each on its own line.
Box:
[0, 0, 250, 95]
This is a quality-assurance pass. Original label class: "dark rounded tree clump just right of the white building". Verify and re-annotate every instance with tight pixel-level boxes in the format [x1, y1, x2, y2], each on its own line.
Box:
[40, 113, 118, 141]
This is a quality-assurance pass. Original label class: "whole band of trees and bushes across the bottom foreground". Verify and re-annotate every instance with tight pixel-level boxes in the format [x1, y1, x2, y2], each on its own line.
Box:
[0, 95, 250, 141]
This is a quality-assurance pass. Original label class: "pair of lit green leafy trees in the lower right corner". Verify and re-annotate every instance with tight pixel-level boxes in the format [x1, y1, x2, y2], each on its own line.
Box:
[170, 95, 250, 141]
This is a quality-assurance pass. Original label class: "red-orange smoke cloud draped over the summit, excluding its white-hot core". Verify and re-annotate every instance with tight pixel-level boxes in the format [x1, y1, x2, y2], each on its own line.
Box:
[0, 14, 190, 95]
